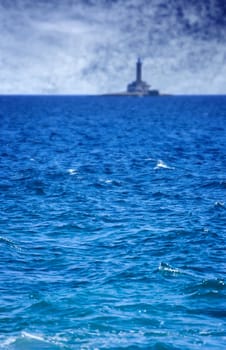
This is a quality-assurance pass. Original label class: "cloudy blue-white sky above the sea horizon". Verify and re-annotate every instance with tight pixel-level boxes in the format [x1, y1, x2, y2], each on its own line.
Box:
[0, 0, 226, 94]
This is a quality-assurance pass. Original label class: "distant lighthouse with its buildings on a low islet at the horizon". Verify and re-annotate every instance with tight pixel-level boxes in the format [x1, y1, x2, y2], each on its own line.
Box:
[105, 58, 160, 96]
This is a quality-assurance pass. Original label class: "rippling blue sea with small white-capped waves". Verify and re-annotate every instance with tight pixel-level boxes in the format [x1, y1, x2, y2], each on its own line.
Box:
[0, 96, 226, 350]
